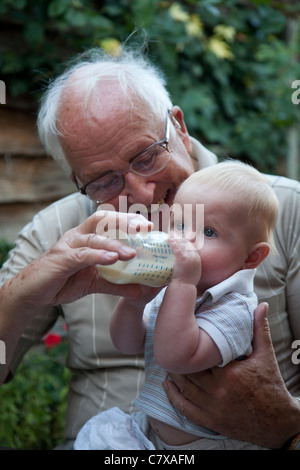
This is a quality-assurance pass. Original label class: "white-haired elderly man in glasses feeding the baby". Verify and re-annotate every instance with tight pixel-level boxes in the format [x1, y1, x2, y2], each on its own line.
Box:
[0, 47, 300, 448]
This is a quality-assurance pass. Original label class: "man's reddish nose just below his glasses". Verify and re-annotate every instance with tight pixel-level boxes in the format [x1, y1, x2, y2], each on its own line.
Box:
[122, 171, 156, 207]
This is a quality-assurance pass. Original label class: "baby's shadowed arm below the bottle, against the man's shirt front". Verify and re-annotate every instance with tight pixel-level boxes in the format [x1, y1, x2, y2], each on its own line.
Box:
[110, 286, 160, 354]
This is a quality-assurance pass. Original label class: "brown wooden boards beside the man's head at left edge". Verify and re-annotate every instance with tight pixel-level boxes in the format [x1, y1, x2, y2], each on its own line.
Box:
[0, 105, 74, 241]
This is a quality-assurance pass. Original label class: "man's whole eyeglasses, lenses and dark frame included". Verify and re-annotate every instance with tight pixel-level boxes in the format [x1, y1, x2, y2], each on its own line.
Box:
[73, 111, 170, 204]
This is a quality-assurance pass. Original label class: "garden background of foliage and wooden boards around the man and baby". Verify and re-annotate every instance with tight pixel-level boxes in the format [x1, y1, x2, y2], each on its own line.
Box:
[0, 0, 300, 449]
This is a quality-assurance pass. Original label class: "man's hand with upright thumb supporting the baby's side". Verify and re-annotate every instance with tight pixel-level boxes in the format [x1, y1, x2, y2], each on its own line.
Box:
[164, 304, 300, 448]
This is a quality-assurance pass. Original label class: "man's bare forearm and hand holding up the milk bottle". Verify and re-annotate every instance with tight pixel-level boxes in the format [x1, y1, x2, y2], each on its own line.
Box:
[0, 211, 152, 383]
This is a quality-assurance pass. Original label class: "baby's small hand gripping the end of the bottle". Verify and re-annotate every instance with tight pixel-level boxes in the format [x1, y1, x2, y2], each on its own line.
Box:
[169, 236, 201, 286]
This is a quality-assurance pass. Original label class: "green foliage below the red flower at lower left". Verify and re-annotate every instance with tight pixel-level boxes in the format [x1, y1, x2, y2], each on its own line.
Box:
[0, 343, 70, 450]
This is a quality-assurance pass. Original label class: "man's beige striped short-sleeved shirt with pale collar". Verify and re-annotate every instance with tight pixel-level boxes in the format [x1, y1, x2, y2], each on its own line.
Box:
[0, 139, 300, 439]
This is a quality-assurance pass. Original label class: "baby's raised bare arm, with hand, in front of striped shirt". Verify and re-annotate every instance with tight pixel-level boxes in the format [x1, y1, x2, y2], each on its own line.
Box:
[154, 239, 221, 374]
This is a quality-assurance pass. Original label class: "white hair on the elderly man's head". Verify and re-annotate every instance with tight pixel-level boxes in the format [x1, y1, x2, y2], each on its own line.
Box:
[37, 48, 172, 170]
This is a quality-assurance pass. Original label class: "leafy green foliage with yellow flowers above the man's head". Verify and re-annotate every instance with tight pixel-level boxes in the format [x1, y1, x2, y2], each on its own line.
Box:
[0, 0, 300, 172]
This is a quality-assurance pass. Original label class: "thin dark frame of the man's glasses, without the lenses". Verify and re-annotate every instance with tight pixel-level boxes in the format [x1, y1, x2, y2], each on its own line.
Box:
[72, 110, 171, 204]
